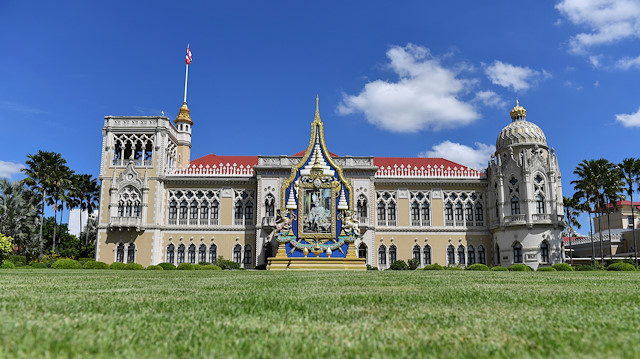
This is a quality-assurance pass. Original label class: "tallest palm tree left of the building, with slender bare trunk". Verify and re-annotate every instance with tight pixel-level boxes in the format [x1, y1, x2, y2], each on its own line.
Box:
[22, 150, 67, 256]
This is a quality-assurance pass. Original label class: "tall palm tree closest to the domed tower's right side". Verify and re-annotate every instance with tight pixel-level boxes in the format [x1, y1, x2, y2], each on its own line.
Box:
[571, 158, 610, 264]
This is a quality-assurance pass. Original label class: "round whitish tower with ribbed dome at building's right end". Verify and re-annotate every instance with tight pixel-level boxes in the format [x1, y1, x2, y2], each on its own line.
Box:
[487, 100, 565, 269]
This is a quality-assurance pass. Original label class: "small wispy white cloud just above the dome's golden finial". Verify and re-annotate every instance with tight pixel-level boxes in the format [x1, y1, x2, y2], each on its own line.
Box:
[484, 60, 551, 91]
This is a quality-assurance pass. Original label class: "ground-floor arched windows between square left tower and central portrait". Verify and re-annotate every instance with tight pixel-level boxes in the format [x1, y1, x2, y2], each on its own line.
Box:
[165, 243, 253, 267]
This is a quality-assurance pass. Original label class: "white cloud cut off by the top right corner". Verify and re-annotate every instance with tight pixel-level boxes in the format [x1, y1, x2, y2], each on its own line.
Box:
[556, 0, 640, 54]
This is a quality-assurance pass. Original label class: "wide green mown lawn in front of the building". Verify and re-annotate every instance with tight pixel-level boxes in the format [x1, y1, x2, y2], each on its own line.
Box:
[0, 269, 640, 359]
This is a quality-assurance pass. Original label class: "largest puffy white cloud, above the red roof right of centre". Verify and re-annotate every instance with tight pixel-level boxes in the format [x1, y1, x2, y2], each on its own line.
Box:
[337, 44, 480, 132]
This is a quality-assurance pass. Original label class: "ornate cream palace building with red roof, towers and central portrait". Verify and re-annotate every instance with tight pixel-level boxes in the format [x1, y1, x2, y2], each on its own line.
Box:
[96, 98, 565, 270]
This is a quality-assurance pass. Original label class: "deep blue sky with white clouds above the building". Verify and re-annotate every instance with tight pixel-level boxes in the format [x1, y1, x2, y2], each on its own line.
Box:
[0, 0, 640, 231]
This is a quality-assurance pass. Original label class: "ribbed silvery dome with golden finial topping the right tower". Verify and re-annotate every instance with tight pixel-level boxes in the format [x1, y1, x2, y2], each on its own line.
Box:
[496, 100, 547, 151]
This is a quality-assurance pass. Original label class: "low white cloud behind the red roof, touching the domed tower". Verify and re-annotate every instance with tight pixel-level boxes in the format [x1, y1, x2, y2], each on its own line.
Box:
[418, 140, 496, 170]
